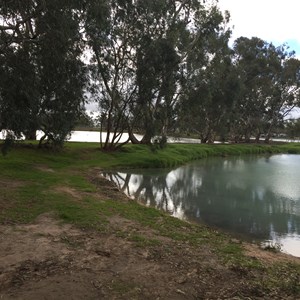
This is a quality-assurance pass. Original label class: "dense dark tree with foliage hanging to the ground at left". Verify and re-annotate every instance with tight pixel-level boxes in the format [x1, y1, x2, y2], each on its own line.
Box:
[36, 0, 87, 145]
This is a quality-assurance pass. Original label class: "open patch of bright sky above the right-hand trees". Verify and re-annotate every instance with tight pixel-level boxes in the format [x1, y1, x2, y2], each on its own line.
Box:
[218, 0, 300, 58]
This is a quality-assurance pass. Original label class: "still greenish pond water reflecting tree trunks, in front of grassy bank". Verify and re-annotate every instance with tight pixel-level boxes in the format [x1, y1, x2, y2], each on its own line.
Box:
[104, 155, 300, 257]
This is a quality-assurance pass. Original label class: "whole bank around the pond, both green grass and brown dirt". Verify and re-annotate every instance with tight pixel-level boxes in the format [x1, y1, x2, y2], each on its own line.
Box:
[0, 144, 300, 299]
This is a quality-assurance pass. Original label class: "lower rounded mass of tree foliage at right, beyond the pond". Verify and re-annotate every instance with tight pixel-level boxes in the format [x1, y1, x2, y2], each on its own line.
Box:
[179, 36, 300, 143]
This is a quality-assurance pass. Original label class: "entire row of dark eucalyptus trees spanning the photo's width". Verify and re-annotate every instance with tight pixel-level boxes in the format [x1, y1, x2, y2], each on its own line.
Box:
[0, 0, 300, 150]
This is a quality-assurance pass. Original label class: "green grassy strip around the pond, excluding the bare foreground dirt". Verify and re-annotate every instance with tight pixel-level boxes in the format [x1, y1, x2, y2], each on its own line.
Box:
[0, 143, 300, 297]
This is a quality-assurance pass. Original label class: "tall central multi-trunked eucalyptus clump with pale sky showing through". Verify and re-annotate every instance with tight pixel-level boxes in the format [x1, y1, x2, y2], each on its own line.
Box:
[85, 0, 234, 150]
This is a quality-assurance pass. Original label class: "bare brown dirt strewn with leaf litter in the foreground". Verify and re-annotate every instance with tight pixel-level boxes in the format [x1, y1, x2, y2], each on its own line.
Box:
[0, 177, 293, 300]
